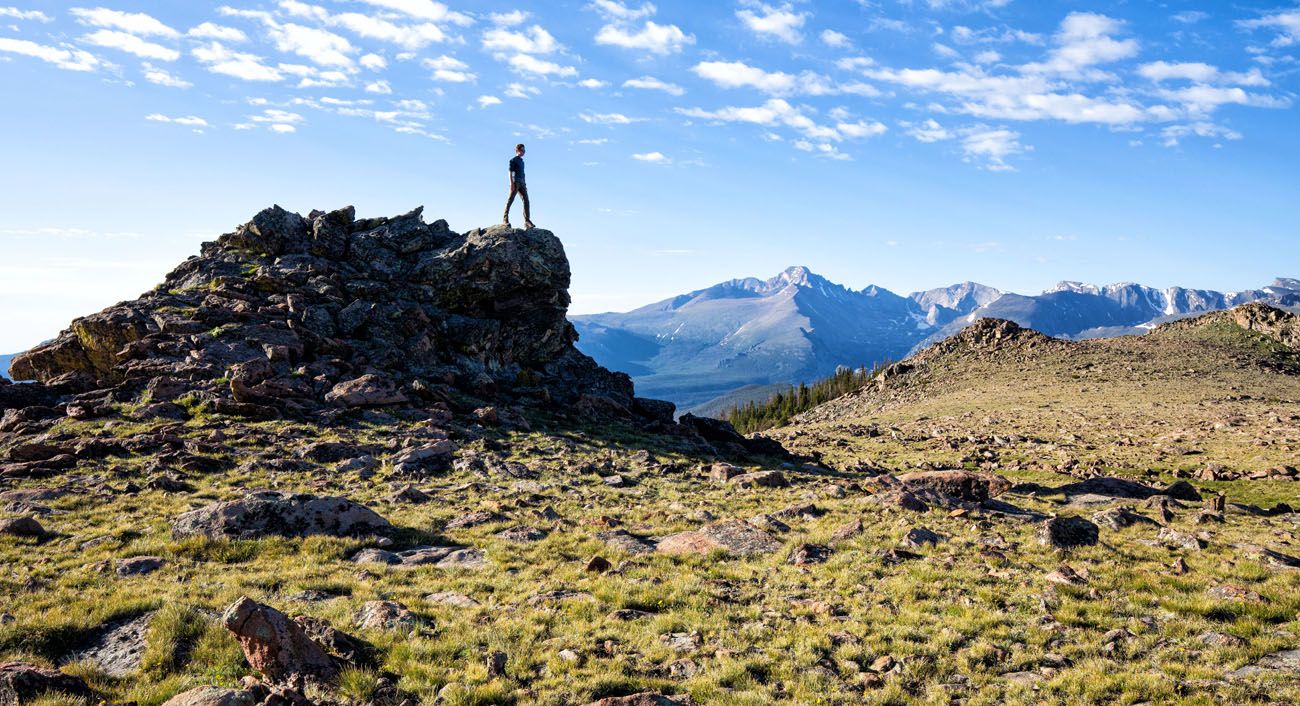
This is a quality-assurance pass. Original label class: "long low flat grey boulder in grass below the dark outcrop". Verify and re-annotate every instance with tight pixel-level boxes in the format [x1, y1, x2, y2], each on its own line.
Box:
[172, 490, 393, 538]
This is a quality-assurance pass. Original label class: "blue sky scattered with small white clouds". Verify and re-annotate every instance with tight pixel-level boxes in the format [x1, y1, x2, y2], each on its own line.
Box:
[0, 0, 1300, 351]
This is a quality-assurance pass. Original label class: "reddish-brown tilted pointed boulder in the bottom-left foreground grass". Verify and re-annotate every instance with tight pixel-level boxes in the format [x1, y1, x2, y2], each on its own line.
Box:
[221, 595, 339, 684]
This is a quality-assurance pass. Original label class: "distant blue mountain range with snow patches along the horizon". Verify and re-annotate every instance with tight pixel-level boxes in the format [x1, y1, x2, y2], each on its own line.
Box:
[571, 267, 1300, 412]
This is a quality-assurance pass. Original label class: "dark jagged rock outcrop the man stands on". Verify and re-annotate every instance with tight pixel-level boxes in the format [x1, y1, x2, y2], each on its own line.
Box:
[0, 207, 660, 421]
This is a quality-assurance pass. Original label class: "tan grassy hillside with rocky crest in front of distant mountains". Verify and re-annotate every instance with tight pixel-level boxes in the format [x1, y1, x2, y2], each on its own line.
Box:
[771, 304, 1300, 478]
